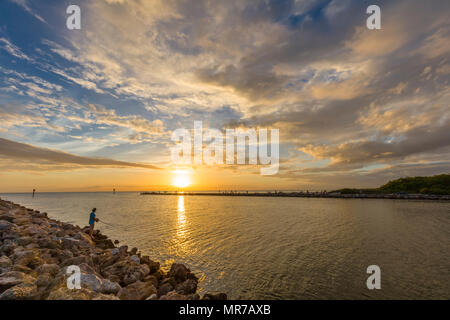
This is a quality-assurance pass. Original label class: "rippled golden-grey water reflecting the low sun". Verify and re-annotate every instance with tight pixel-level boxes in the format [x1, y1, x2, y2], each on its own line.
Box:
[0, 193, 450, 299]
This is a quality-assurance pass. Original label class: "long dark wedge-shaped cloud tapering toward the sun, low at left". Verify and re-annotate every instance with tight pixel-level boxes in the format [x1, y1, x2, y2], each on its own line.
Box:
[0, 138, 159, 169]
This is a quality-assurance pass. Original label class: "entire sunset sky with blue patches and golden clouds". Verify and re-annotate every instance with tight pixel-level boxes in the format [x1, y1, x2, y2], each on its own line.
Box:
[0, 0, 450, 192]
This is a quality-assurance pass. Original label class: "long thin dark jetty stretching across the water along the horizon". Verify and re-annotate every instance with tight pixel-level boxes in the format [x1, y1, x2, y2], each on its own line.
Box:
[140, 191, 450, 201]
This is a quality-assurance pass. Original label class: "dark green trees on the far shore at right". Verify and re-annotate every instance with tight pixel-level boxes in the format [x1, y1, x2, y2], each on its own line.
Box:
[334, 174, 450, 195]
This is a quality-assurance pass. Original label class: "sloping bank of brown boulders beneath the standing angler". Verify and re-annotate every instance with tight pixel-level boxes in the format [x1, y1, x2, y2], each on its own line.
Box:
[0, 199, 227, 300]
